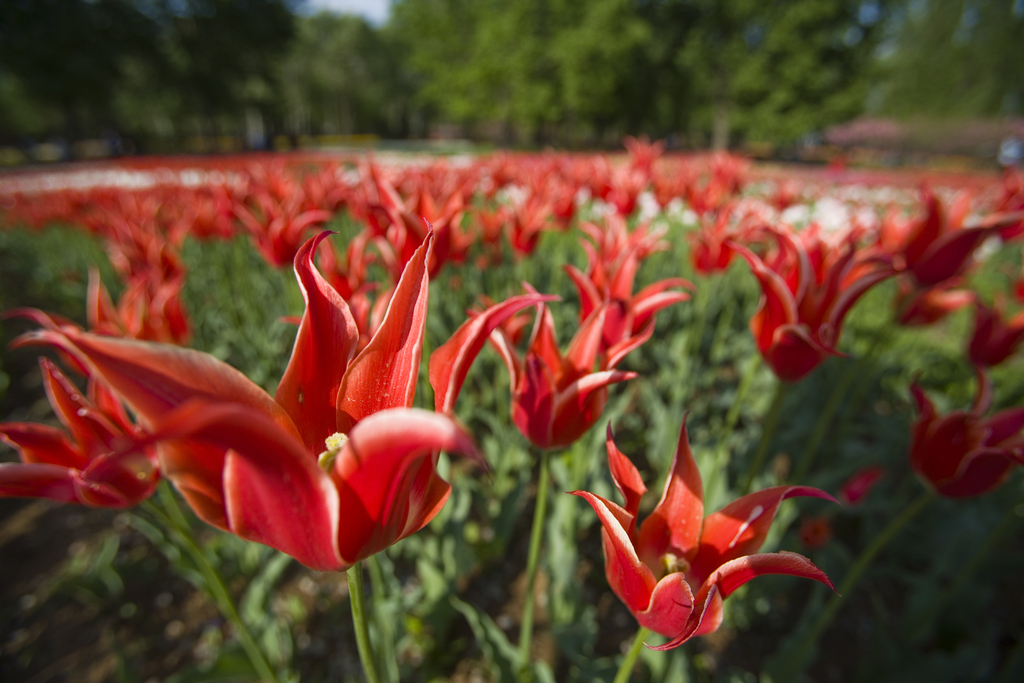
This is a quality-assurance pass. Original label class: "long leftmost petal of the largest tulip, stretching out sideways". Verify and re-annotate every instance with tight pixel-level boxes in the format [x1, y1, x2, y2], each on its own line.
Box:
[18, 328, 298, 435]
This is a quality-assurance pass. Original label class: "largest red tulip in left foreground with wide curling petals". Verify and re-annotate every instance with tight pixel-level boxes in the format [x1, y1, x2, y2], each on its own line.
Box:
[9, 233, 495, 570]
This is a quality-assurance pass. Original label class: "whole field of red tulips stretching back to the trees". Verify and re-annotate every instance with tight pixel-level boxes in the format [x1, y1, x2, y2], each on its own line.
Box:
[0, 148, 1024, 683]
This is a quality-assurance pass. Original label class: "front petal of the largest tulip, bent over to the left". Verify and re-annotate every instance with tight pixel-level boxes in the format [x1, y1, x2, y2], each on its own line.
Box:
[146, 401, 347, 571]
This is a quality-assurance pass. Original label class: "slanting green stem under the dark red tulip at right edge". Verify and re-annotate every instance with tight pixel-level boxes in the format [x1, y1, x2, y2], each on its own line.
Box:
[772, 490, 935, 681]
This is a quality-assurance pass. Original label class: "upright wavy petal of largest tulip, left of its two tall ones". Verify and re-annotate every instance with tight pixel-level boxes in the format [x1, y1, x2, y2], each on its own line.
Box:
[274, 233, 359, 453]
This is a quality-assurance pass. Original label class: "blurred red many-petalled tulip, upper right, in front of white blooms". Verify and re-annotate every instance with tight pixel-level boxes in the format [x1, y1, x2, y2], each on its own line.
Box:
[729, 226, 894, 382]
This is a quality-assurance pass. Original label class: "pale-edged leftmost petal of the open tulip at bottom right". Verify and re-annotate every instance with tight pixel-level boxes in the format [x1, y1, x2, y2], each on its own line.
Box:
[571, 490, 657, 614]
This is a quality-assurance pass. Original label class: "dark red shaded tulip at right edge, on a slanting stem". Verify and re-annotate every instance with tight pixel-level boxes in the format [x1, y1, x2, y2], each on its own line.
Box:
[910, 368, 1024, 498]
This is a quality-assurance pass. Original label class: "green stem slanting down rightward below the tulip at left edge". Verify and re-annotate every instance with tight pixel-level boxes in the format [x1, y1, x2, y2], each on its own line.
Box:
[143, 483, 278, 683]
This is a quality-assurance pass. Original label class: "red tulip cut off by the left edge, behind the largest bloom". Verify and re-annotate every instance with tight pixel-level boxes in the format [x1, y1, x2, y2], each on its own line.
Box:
[0, 358, 160, 508]
